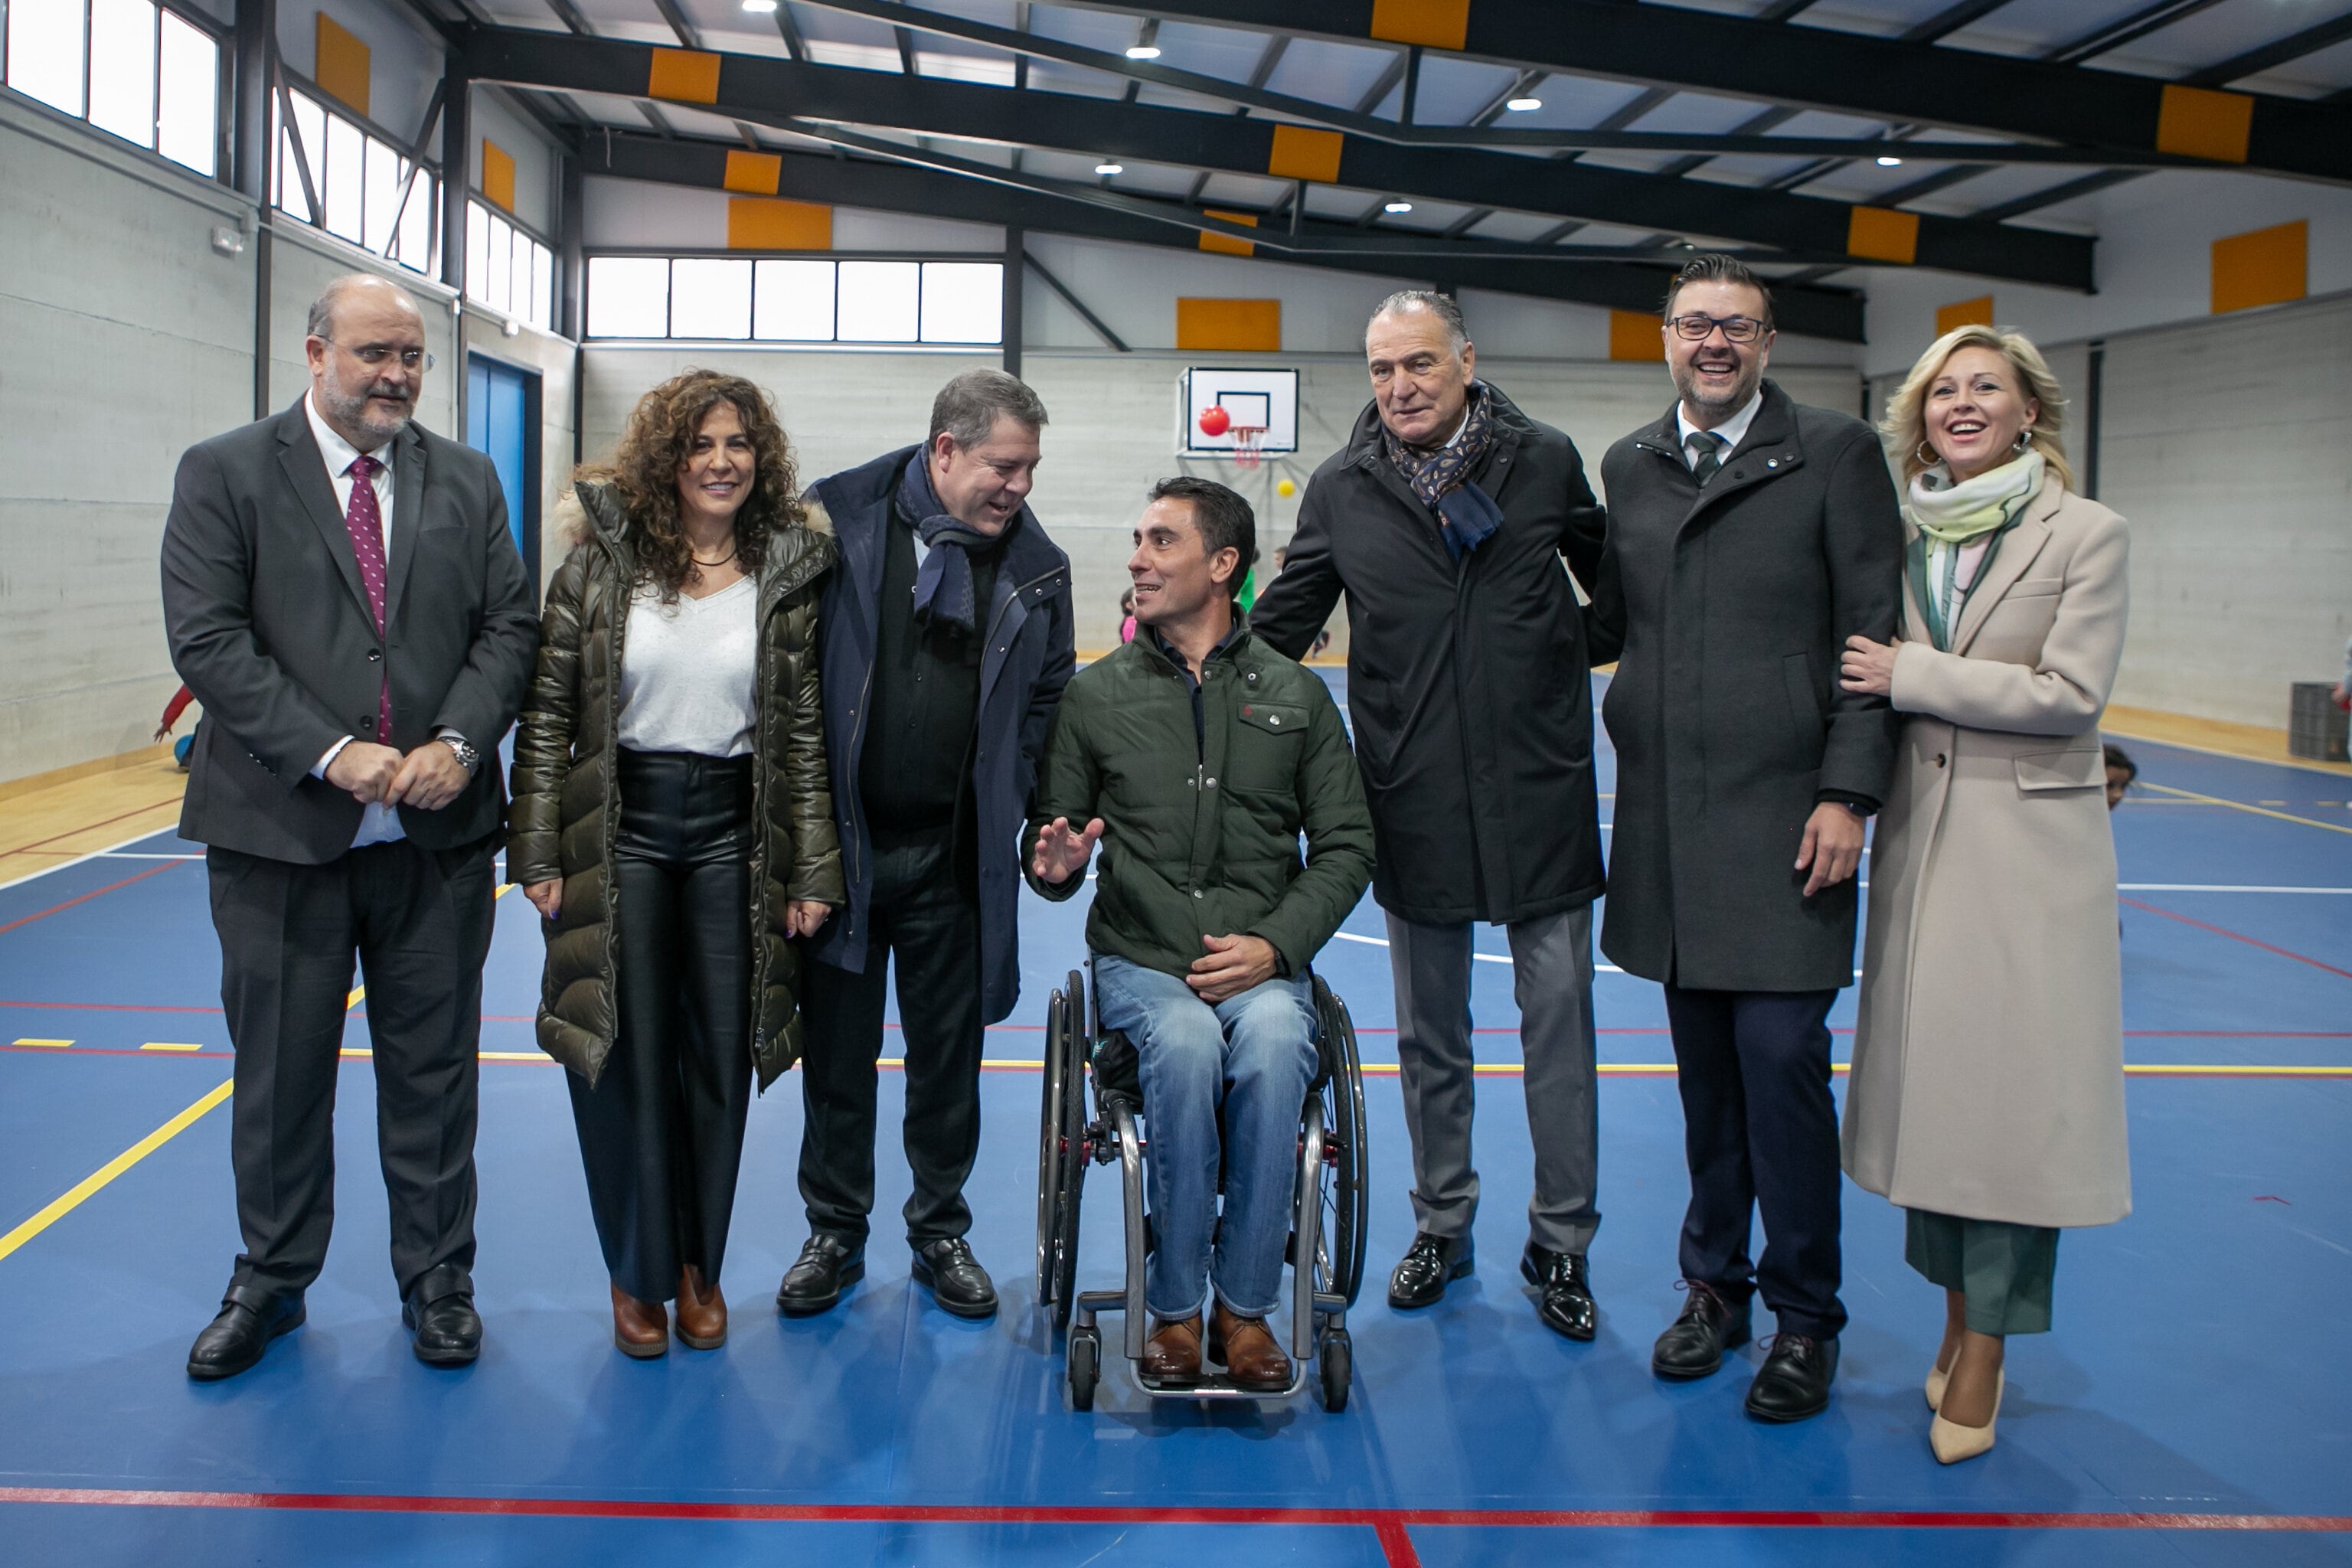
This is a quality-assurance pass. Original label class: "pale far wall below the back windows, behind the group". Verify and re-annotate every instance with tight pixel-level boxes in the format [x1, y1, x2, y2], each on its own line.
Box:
[581, 343, 1860, 648]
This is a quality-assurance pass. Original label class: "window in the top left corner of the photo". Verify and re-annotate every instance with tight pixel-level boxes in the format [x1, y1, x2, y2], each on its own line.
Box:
[5, 0, 221, 174]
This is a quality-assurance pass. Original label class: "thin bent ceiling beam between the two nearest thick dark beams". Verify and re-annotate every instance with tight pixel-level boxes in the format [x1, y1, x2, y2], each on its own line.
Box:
[802, 0, 2207, 169]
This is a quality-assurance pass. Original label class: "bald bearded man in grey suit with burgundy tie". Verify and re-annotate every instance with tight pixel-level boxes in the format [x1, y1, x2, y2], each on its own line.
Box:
[162, 275, 538, 1380]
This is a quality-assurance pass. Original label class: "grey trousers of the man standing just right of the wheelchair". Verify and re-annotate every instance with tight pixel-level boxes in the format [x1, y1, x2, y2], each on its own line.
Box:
[1387, 905, 1602, 1253]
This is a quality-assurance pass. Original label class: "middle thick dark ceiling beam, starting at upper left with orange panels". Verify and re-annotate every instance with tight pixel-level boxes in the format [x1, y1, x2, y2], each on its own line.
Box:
[466, 28, 2093, 289]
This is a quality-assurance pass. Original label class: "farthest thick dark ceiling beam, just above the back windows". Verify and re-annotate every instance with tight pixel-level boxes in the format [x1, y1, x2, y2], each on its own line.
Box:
[581, 132, 1863, 343]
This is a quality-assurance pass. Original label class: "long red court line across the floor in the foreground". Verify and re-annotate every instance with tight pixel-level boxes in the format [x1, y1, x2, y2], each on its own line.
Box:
[0, 1486, 2352, 1561]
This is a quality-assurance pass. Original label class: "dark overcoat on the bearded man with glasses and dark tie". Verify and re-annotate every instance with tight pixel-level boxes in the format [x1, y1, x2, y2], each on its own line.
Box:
[1592, 381, 1903, 992]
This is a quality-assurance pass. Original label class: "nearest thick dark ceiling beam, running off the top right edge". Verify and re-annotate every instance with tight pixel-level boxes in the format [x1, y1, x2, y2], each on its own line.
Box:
[1039, 0, 2352, 183]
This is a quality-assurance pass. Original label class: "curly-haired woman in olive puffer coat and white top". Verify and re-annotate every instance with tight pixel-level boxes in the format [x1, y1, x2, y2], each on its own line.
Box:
[505, 371, 844, 1357]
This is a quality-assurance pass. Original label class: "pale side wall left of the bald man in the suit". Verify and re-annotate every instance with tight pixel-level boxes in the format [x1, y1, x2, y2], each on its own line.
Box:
[0, 94, 254, 780]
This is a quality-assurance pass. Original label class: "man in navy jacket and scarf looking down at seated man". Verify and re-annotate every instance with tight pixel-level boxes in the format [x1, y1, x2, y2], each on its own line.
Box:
[776, 369, 1077, 1316]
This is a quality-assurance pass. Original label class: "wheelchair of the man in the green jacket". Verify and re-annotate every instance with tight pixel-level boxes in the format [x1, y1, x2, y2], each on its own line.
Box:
[1037, 969, 1367, 1413]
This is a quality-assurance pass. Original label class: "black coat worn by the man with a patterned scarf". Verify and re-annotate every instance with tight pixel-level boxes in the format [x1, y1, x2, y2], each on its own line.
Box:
[1249, 388, 1602, 926]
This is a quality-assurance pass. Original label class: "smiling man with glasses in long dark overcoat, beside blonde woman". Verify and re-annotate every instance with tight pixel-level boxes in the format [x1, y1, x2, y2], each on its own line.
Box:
[1592, 256, 1903, 1423]
